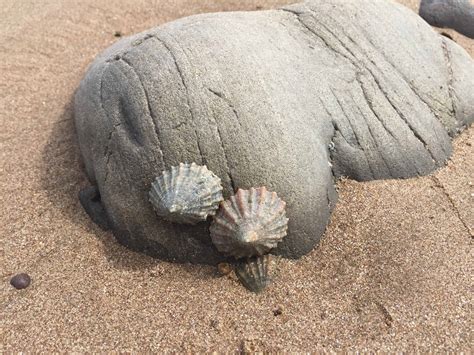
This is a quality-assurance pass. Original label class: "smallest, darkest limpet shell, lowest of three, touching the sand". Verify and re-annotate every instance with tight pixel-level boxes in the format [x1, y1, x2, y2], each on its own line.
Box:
[235, 254, 274, 293]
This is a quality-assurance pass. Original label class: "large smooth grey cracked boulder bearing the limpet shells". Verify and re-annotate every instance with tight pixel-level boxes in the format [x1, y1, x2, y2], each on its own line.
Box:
[75, 0, 474, 263]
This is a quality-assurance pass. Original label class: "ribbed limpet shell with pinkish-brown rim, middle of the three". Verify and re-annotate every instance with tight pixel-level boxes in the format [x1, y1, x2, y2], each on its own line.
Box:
[210, 187, 288, 258]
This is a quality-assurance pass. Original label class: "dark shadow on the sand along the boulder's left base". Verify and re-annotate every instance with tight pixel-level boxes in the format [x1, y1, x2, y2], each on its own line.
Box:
[40, 97, 215, 278]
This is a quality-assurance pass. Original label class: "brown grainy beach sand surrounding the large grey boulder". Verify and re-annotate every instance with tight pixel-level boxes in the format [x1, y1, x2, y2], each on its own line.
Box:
[0, 0, 474, 352]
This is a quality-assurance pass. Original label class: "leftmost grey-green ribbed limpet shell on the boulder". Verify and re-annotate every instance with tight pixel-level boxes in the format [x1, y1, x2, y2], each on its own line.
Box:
[149, 163, 223, 224]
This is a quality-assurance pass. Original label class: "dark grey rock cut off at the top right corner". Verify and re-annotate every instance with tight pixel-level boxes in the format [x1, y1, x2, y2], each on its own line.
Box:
[420, 0, 474, 38]
